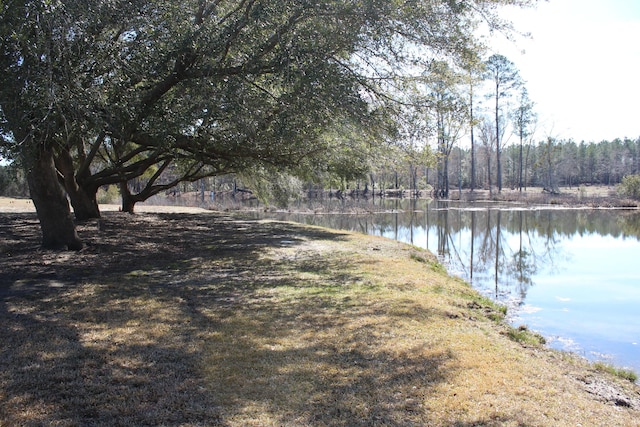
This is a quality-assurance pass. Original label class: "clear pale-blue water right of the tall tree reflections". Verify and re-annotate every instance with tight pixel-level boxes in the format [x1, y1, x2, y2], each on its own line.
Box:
[513, 234, 640, 372]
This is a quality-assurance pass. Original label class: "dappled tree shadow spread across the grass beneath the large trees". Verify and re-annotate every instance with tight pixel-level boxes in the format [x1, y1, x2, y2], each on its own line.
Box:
[0, 214, 528, 426]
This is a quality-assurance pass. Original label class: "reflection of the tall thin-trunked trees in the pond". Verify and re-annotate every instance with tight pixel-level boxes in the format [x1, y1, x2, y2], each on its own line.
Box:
[430, 209, 559, 304]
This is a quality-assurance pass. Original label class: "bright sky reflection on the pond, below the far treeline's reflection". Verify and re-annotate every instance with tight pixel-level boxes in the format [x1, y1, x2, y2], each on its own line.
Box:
[428, 224, 640, 373]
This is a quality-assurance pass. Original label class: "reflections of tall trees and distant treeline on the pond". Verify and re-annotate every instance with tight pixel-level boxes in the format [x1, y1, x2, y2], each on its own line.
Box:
[410, 204, 640, 304]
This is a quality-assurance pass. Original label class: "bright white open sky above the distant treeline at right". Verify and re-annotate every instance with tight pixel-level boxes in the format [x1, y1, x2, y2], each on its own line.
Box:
[490, 0, 640, 142]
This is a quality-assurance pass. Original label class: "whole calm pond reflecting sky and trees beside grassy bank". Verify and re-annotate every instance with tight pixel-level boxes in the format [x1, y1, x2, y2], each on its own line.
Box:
[250, 200, 640, 372]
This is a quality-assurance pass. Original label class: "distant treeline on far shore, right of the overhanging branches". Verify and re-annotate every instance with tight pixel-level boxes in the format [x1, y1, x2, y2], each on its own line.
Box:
[358, 138, 640, 196]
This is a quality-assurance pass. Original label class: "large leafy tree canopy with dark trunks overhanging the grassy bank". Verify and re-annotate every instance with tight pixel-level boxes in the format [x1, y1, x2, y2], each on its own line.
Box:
[0, 0, 535, 248]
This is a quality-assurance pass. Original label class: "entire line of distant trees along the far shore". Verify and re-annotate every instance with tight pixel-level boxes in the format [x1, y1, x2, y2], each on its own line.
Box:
[5, 138, 640, 203]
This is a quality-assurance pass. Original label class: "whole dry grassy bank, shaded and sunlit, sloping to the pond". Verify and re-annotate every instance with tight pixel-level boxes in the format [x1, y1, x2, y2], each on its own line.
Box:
[0, 212, 640, 426]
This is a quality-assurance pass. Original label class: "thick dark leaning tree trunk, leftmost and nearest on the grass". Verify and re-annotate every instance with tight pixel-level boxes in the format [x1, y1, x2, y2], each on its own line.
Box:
[27, 150, 83, 251]
